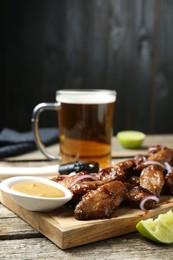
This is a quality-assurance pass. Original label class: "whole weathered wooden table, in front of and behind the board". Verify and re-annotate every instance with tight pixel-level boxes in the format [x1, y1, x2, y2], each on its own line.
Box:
[0, 135, 173, 260]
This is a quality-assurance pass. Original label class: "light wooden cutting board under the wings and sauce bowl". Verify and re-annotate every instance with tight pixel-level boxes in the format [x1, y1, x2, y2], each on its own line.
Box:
[0, 192, 173, 249]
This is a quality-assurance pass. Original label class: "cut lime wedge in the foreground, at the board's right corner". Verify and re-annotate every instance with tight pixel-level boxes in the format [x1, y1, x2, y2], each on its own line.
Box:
[136, 210, 173, 244]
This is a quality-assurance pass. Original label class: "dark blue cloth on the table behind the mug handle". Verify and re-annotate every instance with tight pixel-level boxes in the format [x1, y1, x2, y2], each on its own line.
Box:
[0, 128, 59, 158]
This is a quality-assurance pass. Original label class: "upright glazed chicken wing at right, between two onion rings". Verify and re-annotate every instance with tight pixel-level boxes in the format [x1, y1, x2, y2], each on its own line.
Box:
[139, 165, 165, 197]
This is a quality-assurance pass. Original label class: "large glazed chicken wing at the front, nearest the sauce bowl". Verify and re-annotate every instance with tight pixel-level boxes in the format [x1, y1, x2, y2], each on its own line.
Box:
[74, 181, 125, 220]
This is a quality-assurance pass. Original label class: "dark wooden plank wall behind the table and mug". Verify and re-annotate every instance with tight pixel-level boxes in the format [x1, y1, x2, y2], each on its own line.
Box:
[0, 0, 173, 134]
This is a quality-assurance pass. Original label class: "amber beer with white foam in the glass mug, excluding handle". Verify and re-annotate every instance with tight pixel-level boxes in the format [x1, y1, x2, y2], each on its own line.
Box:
[56, 90, 115, 167]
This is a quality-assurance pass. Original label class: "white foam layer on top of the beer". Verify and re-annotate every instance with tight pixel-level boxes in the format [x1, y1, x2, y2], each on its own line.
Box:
[56, 90, 116, 104]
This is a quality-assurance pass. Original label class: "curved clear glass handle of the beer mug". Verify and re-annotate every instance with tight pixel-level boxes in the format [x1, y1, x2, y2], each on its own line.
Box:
[31, 102, 60, 160]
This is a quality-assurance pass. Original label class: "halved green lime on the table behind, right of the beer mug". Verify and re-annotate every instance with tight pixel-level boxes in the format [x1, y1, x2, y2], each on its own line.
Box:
[117, 131, 145, 149]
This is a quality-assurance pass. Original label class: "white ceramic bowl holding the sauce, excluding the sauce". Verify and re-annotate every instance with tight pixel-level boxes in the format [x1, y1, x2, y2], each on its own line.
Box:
[0, 176, 72, 212]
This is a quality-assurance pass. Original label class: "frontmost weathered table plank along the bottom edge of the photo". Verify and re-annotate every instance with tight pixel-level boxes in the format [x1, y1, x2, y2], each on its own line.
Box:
[0, 233, 173, 260]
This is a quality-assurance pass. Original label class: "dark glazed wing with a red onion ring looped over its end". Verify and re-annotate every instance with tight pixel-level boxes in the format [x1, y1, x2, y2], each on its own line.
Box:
[125, 185, 156, 209]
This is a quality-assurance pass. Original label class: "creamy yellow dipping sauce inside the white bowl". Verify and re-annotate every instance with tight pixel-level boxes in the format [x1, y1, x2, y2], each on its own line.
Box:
[11, 181, 65, 198]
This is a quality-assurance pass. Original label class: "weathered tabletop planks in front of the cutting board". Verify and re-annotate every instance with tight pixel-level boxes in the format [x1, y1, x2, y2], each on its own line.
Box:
[0, 201, 173, 260]
